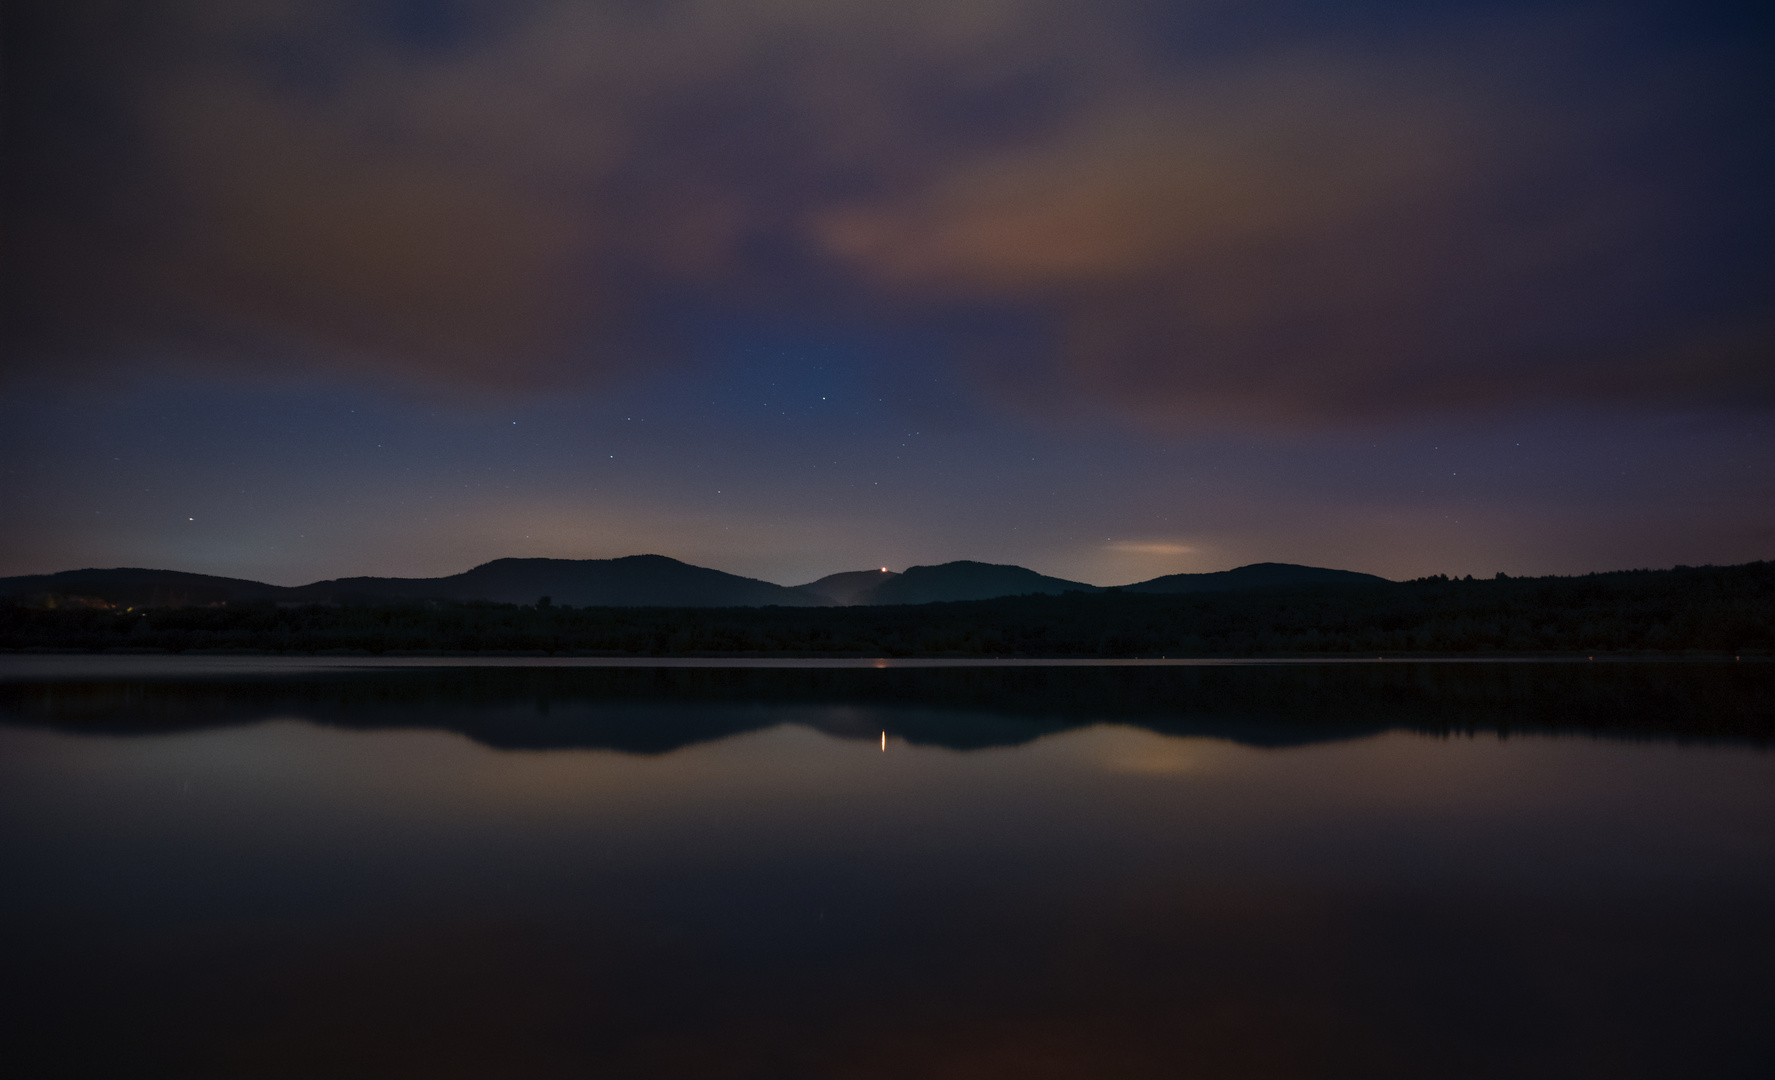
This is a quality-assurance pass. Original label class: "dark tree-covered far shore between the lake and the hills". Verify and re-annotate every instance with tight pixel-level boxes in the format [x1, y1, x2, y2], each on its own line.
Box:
[0, 563, 1775, 657]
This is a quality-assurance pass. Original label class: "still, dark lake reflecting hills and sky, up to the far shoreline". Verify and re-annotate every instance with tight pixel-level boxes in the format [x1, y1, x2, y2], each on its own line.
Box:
[0, 657, 1775, 1078]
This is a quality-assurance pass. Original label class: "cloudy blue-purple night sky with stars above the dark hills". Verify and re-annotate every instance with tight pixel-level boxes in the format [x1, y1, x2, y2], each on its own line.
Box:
[0, 0, 1775, 584]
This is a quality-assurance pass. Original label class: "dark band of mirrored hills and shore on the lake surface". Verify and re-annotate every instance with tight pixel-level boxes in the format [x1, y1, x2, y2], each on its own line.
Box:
[0, 663, 1775, 753]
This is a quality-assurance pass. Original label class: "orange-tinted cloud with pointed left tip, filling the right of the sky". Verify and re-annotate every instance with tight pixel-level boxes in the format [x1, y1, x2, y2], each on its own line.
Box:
[820, 24, 1775, 423]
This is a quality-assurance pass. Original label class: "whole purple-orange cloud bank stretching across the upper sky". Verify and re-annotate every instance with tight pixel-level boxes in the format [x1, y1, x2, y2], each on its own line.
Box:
[5, 0, 1775, 419]
